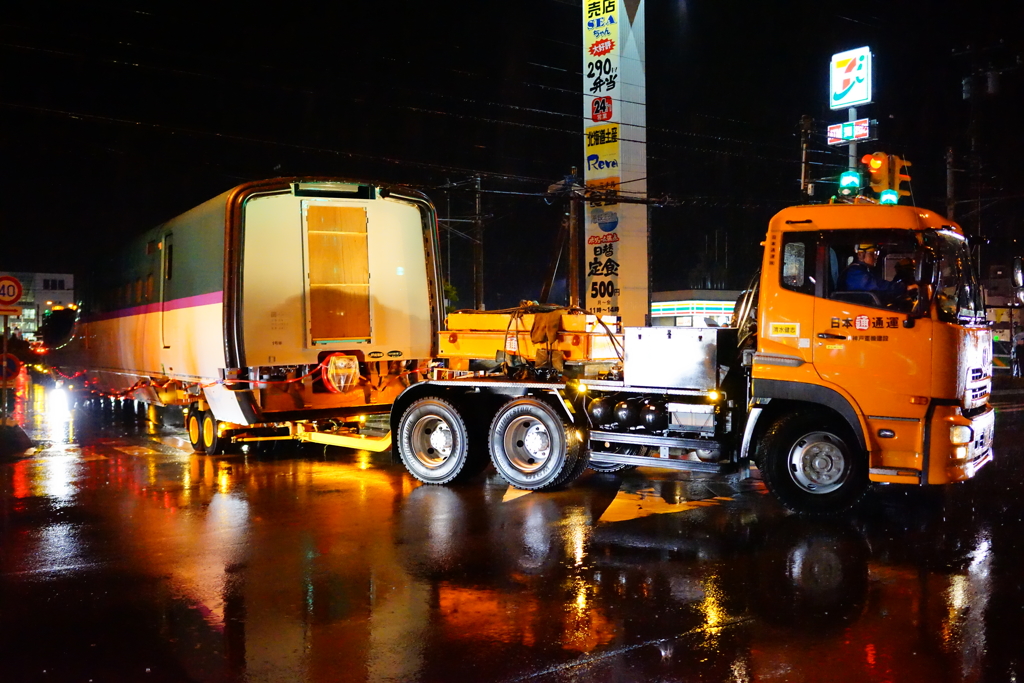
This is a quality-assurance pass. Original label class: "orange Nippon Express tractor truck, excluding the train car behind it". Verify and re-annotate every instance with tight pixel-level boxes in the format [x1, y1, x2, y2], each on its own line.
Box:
[390, 201, 993, 514]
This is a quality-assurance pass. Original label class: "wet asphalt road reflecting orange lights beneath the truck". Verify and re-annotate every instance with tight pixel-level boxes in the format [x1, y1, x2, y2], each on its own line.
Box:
[0, 391, 1024, 683]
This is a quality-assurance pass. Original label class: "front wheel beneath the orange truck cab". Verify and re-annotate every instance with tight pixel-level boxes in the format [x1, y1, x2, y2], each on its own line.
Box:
[758, 412, 868, 516]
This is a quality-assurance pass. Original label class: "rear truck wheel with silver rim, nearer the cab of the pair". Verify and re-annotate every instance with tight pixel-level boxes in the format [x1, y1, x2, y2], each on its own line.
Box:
[488, 396, 586, 490]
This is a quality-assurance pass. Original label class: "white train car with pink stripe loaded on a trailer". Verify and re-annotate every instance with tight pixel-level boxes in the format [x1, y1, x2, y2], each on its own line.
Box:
[58, 177, 442, 454]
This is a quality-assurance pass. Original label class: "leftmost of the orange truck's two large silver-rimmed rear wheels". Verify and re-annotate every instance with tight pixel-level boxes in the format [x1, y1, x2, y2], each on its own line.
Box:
[398, 396, 487, 484]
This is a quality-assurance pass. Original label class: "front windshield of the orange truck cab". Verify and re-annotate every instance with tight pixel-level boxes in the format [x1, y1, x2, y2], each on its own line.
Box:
[926, 230, 985, 324]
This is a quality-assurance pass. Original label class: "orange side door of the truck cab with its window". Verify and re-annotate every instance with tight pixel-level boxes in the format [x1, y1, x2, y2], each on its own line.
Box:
[811, 230, 932, 419]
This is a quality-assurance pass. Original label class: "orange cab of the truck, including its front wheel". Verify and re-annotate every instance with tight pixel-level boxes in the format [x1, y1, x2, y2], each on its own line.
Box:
[746, 203, 993, 508]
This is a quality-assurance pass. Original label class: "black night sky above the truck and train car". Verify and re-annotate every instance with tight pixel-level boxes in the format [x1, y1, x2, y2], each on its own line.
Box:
[0, 0, 1024, 308]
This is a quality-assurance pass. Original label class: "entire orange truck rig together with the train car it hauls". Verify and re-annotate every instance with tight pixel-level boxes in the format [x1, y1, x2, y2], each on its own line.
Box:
[61, 178, 995, 514]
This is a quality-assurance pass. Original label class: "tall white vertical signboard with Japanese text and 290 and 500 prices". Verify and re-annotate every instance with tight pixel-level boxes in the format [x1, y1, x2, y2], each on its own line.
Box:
[582, 0, 649, 326]
